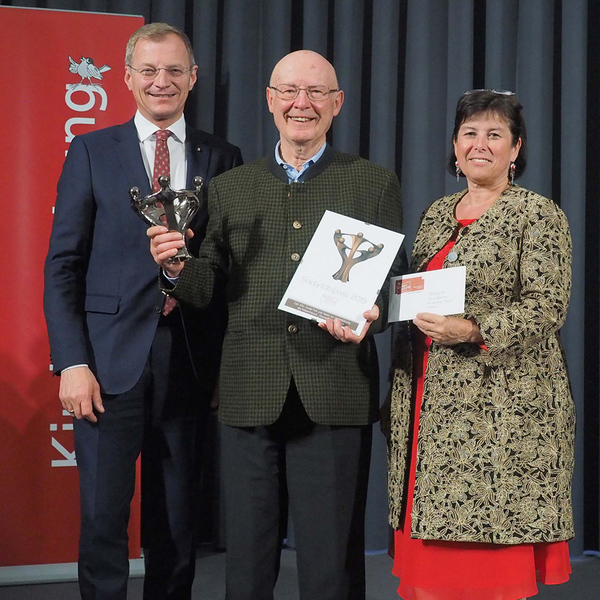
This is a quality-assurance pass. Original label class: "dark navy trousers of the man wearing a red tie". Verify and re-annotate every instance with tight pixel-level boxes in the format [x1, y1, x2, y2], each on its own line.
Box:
[74, 309, 205, 600]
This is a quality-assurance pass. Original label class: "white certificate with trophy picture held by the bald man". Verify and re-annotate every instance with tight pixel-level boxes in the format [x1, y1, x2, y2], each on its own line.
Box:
[278, 210, 404, 335]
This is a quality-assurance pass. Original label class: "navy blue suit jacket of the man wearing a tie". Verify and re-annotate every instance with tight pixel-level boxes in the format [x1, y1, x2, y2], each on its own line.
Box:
[44, 120, 242, 394]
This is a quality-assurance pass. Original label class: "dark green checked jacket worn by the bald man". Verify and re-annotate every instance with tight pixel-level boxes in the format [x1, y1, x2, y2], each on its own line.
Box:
[170, 146, 403, 427]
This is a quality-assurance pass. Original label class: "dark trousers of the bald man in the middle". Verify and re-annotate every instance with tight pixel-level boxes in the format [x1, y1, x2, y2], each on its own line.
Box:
[223, 381, 372, 600]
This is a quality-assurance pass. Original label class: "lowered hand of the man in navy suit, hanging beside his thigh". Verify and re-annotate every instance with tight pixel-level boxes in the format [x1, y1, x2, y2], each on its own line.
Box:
[58, 366, 104, 423]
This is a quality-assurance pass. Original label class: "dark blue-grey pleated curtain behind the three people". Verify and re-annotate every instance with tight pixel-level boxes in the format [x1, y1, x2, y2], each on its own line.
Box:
[7, 0, 600, 556]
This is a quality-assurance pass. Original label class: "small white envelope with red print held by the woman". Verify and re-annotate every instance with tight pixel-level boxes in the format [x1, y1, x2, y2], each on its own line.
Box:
[388, 267, 467, 321]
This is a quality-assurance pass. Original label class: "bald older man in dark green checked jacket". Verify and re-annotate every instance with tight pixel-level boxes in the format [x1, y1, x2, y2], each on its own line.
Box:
[149, 51, 403, 600]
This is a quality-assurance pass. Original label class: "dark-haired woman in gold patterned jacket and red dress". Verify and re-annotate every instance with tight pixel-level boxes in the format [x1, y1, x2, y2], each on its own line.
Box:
[389, 90, 575, 600]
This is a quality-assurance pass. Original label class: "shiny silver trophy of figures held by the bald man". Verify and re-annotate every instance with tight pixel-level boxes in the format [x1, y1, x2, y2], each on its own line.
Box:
[129, 175, 204, 263]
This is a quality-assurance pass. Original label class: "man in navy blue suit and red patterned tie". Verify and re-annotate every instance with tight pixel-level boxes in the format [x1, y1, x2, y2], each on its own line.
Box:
[44, 23, 242, 600]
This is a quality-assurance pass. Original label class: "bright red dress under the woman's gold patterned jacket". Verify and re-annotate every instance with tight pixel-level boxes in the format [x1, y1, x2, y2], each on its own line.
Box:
[393, 219, 571, 600]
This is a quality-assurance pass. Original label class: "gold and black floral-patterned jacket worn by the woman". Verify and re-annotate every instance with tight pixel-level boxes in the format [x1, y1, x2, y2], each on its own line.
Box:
[389, 185, 575, 544]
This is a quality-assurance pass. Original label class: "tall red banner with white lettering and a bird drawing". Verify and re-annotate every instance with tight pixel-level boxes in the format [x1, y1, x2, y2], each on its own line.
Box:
[0, 6, 144, 566]
